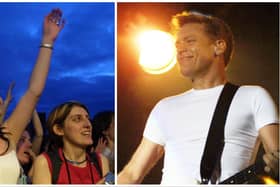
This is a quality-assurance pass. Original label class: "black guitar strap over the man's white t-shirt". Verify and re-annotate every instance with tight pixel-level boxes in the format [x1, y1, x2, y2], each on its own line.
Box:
[200, 82, 239, 184]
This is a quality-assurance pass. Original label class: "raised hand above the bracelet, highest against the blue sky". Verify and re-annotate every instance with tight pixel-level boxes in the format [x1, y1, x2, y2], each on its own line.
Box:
[42, 8, 65, 44]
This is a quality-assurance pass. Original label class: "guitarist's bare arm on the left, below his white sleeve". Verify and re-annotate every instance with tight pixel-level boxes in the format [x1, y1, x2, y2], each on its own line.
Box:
[117, 138, 164, 184]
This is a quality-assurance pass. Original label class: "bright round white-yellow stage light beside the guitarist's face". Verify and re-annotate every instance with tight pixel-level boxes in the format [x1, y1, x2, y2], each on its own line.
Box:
[138, 30, 176, 74]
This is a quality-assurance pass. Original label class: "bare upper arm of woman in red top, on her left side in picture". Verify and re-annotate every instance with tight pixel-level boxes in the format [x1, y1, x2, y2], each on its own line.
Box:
[32, 154, 52, 184]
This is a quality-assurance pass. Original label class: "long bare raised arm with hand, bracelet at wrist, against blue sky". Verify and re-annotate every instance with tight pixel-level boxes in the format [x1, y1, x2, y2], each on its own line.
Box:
[6, 9, 63, 145]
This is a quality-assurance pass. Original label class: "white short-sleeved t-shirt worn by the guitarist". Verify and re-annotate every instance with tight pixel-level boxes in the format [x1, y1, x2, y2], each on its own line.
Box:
[144, 85, 278, 185]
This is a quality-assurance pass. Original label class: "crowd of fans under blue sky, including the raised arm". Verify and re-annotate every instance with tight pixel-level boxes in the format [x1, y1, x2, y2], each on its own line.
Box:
[0, 9, 114, 184]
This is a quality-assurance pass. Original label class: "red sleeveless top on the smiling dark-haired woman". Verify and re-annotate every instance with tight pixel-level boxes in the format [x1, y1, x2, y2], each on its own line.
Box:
[43, 148, 102, 184]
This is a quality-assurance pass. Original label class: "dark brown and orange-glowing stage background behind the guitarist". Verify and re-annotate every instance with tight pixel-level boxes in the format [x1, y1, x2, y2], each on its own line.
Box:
[117, 3, 279, 184]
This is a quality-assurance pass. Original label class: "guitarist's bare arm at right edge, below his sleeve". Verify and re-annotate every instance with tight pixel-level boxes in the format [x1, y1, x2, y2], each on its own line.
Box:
[259, 123, 279, 176]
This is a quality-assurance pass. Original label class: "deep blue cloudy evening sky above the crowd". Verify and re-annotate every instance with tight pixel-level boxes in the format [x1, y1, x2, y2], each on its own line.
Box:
[0, 3, 115, 120]
